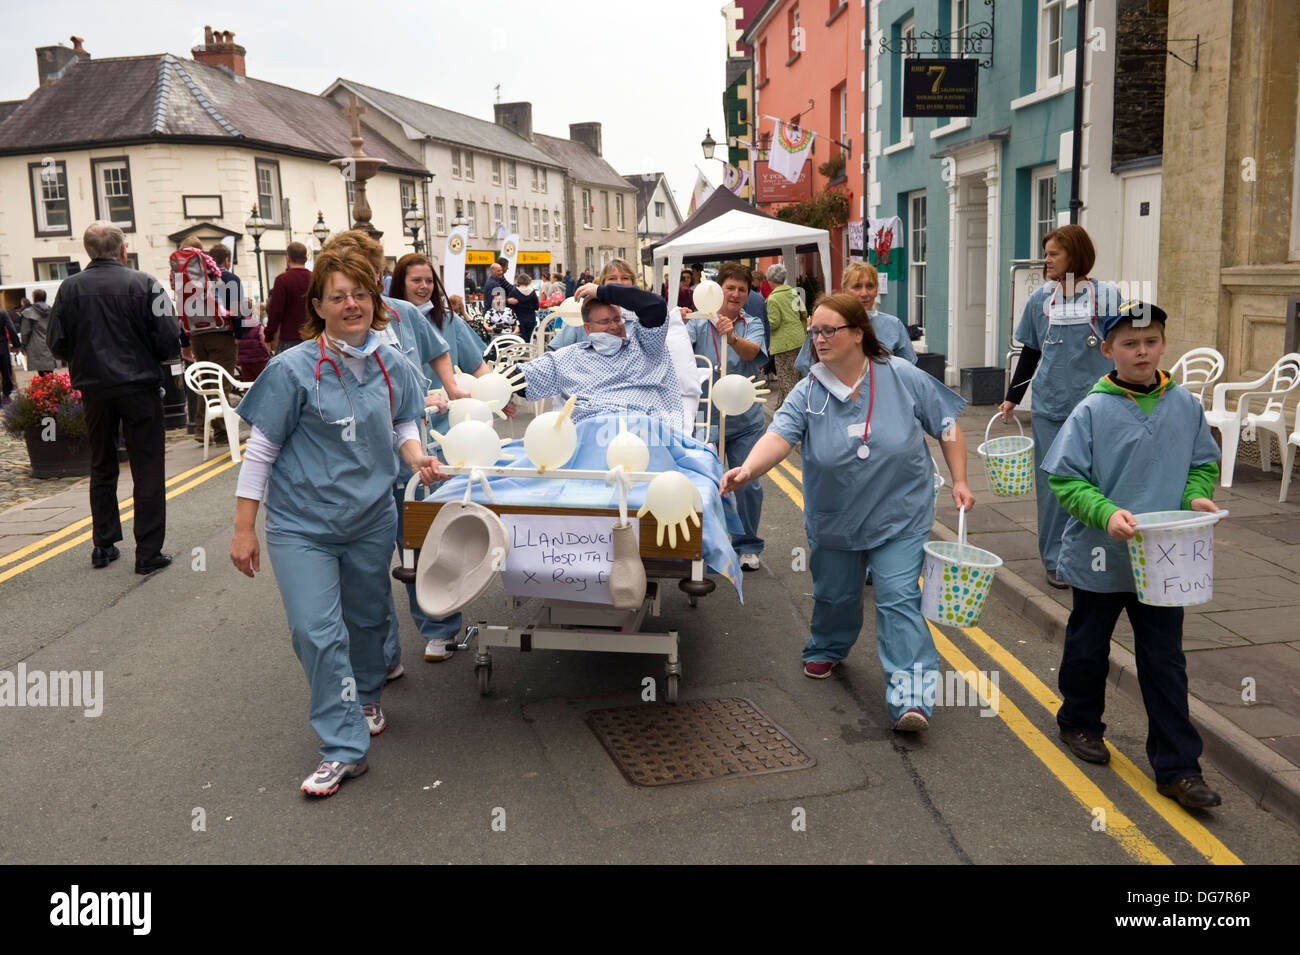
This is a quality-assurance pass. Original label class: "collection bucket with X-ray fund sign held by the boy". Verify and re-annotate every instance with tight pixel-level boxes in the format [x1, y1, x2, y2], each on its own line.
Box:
[1128, 511, 1227, 607]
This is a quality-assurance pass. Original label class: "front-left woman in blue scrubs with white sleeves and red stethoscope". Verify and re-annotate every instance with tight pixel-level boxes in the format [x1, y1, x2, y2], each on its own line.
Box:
[230, 249, 441, 796]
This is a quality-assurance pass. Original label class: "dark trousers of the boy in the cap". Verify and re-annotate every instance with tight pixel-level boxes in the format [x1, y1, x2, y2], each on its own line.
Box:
[1057, 587, 1201, 782]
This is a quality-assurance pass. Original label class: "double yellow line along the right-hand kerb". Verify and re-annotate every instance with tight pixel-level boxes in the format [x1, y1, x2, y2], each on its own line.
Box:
[767, 461, 1242, 865]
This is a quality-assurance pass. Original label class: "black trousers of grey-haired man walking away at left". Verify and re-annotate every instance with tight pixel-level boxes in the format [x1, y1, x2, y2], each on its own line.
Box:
[85, 387, 166, 560]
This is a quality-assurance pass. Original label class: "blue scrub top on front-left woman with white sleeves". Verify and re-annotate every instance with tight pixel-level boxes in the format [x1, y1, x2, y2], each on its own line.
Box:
[238, 340, 425, 543]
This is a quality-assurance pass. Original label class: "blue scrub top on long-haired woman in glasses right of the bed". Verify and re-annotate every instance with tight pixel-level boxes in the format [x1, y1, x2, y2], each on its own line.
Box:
[768, 356, 966, 551]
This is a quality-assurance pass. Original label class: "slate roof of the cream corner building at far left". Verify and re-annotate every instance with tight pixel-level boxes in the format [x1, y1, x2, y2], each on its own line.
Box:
[0, 53, 428, 175]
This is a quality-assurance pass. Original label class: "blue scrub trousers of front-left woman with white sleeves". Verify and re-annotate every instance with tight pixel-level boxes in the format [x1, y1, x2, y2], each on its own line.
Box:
[267, 521, 393, 763]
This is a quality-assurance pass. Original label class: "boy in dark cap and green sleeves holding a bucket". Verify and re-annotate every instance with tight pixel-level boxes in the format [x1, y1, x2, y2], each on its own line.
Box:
[1043, 301, 1221, 809]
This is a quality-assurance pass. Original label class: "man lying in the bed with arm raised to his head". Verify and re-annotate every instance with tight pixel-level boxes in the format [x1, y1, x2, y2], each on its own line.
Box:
[519, 285, 685, 430]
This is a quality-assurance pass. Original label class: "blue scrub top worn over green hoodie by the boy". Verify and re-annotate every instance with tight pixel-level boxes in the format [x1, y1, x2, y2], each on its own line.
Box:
[1034, 385, 1219, 594]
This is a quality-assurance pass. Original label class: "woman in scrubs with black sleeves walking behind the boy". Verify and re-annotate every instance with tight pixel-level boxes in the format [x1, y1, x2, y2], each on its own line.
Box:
[997, 225, 1119, 590]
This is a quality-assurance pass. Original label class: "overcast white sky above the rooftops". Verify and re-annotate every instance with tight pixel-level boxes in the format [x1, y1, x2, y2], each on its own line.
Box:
[0, 0, 725, 216]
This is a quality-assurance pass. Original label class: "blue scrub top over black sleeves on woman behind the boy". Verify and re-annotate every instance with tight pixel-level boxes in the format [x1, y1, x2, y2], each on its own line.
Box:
[1011, 282, 1119, 421]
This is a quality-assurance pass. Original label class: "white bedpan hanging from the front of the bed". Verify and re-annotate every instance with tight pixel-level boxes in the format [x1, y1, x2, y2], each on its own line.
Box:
[415, 502, 510, 618]
